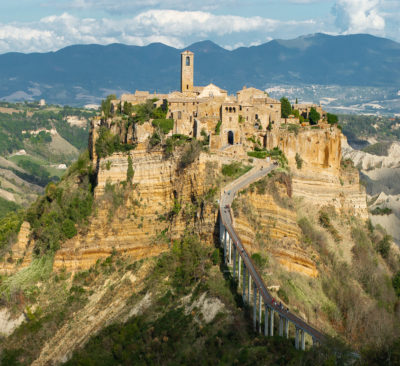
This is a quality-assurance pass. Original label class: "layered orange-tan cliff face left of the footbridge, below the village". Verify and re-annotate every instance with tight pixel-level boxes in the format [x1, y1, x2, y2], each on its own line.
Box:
[54, 145, 220, 271]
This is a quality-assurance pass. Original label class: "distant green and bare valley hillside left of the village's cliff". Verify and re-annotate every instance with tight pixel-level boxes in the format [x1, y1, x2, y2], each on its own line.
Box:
[0, 102, 93, 216]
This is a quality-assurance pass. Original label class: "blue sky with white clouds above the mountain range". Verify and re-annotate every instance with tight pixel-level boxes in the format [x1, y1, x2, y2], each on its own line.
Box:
[0, 0, 400, 53]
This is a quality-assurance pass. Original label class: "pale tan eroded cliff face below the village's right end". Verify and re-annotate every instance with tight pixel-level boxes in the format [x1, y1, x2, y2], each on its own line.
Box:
[267, 127, 368, 220]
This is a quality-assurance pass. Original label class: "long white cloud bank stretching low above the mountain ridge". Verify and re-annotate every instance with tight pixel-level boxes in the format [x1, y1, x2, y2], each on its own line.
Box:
[0, 10, 316, 53]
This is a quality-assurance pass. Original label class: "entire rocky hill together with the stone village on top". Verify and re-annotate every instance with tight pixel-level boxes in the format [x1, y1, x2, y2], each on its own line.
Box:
[4, 47, 399, 365]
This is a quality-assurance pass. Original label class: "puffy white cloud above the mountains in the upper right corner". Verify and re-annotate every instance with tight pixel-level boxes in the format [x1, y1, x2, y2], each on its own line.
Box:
[334, 0, 386, 35]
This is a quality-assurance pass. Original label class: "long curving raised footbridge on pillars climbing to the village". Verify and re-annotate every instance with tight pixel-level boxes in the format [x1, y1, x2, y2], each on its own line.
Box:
[219, 164, 324, 350]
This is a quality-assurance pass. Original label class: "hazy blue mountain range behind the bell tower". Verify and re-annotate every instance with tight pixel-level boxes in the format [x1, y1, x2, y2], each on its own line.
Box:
[0, 34, 400, 105]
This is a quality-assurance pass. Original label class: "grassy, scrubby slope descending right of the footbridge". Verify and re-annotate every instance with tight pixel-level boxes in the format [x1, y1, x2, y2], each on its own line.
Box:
[232, 172, 400, 349]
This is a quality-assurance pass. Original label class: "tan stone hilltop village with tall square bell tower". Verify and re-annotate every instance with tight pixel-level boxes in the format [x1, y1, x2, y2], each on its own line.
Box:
[104, 51, 331, 151]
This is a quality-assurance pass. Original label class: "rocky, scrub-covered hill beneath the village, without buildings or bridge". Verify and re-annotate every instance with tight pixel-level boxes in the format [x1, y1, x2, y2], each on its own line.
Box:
[0, 98, 400, 365]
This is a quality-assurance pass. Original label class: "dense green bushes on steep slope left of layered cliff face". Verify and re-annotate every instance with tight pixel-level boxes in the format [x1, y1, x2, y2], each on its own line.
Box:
[26, 152, 93, 256]
